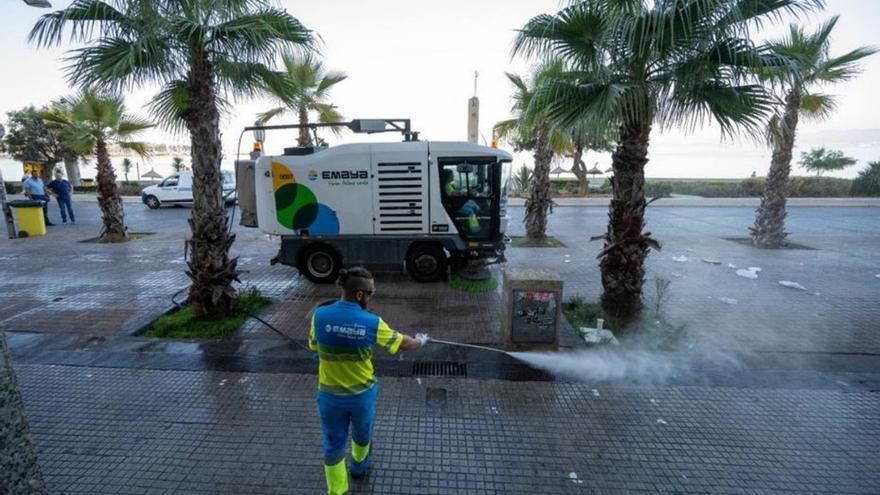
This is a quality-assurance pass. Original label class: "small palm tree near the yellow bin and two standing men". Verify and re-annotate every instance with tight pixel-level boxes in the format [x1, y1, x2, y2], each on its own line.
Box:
[43, 89, 154, 242]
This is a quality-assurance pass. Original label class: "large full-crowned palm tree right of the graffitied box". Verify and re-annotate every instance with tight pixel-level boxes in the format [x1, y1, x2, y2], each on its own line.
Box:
[514, 0, 816, 324]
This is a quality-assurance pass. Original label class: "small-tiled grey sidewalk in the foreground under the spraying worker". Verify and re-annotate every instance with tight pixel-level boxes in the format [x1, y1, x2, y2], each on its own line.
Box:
[17, 365, 880, 495]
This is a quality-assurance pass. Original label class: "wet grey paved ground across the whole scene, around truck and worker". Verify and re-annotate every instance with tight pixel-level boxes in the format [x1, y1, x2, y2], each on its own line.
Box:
[0, 202, 880, 494]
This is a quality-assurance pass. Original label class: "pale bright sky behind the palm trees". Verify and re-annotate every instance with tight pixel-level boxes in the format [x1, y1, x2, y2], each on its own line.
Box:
[0, 0, 880, 177]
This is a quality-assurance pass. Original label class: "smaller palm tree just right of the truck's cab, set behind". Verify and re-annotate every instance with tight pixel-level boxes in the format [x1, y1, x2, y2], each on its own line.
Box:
[494, 61, 569, 240]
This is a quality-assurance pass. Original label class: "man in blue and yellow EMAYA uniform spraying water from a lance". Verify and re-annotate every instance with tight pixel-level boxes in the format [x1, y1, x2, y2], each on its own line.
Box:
[309, 267, 429, 495]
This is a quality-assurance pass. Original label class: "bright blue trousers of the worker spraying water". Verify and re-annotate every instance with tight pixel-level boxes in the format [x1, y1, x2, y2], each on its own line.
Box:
[318, 383, 379, 474]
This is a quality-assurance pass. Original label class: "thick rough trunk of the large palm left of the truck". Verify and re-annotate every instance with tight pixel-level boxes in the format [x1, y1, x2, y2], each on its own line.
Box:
[186, 51, 238, 319]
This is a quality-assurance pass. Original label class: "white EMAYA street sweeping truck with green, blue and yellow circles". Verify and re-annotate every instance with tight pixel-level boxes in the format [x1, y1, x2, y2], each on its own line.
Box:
[236, 119, 512, 283]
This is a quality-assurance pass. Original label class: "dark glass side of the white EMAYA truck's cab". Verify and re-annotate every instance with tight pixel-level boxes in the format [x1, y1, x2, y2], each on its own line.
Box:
[438, 157, 497, 239]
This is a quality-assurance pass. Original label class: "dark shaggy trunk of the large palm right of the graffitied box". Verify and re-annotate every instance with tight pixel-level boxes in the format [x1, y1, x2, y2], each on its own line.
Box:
[600, 124, 656, 324]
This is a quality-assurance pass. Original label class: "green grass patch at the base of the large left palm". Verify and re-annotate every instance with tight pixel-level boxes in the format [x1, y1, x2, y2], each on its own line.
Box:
[145, 287, 272, 339]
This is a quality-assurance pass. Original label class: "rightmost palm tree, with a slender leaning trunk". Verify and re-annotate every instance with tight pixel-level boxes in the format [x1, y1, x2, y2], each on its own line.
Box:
[750, 17, 877, 248]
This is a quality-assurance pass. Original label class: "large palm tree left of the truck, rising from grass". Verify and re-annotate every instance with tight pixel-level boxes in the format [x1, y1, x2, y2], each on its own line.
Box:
[30, 0, 313, 319]
